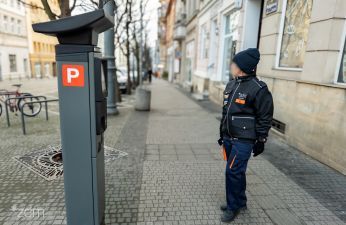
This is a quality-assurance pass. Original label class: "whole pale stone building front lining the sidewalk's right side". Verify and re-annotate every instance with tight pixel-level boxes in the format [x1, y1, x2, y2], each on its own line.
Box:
[159, 0, 346, 174]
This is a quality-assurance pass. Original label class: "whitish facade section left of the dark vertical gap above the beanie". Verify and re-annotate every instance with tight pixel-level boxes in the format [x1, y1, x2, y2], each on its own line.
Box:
[192, 0, 262, 102]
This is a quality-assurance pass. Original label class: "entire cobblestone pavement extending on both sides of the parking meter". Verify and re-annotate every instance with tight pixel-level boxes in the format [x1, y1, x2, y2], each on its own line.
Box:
[0, 79, 346, 225]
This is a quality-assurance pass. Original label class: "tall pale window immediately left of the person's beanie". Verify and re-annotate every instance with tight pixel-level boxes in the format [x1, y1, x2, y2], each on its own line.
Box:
[222, 10, 239, 83]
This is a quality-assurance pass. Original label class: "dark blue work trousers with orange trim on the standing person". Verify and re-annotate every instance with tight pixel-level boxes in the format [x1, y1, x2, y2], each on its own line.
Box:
[224, 138, 253, 211]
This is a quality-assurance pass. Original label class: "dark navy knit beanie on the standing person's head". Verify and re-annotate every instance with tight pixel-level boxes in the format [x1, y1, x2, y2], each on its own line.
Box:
[233, 48, 260, 74]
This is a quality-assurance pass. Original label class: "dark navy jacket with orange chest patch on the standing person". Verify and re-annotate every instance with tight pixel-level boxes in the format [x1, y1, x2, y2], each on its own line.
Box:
[220, 75, 274, 140]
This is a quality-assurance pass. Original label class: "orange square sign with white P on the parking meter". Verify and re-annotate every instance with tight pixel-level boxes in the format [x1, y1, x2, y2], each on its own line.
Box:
[62, 64, 84, 87]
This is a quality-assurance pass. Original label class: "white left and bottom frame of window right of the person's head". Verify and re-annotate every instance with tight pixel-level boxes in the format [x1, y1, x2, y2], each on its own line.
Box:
[275, 0, 303, 72]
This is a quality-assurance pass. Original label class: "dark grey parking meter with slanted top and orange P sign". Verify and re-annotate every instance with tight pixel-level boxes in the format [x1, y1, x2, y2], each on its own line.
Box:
[33, 9, 114, 225]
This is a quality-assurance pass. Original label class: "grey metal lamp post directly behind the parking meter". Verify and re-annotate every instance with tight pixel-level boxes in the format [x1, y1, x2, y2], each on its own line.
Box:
[103, 0, 119, 115]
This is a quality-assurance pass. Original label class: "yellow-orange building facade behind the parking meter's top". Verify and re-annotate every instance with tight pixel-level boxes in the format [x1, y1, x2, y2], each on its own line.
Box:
[27, 0, 59, 78]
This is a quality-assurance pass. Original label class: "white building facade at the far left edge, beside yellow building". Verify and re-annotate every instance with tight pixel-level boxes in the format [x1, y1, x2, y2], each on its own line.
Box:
[0, 0, 30, 80]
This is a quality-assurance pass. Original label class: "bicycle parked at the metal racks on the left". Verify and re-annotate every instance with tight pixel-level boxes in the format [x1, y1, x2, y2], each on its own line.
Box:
[0, 84, 42, 117]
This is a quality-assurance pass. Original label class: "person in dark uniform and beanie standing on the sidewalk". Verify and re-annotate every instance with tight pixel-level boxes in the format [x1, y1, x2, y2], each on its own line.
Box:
[218, 48, 274, 222]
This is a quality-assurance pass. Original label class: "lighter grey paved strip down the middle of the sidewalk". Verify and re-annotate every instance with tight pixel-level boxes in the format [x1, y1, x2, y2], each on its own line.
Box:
[138, 81, 345, 224]
